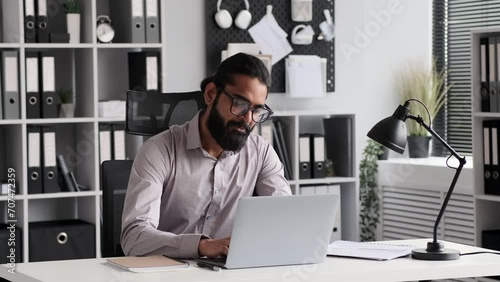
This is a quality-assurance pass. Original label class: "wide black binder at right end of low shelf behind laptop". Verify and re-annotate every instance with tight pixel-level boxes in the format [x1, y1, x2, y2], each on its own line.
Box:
[323, 116, 354, 177]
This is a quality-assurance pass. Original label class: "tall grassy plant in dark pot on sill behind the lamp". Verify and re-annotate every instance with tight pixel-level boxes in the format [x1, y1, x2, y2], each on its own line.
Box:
[398, 64, 450, 158]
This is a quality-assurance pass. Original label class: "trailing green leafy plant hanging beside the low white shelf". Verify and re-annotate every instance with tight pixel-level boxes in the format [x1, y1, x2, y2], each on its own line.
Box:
[359, 139, 384, 242]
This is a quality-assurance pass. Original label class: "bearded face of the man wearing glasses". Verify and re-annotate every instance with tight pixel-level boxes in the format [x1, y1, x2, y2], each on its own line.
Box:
[207, 75, 267, 151]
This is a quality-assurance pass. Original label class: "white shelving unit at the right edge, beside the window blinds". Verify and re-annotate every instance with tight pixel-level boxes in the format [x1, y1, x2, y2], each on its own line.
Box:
[471, 28, 500, 246]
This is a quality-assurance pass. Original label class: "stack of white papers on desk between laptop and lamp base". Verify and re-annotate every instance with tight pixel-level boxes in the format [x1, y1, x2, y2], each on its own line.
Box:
[327, 240, 415, 260]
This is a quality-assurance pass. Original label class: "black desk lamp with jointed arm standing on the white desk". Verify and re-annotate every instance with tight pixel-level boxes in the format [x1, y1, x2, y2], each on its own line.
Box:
[367, 99, 466, 260]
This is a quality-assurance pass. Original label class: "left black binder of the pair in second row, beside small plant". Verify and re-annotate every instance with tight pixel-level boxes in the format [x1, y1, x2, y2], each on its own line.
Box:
[26, 52, 41, 118]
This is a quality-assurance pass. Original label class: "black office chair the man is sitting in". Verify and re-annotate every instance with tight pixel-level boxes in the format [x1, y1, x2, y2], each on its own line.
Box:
[101, 90, 205, 257]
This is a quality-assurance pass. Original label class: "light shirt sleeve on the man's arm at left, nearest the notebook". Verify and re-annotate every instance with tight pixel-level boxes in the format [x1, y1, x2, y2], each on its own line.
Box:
[120, 141, 202, 258]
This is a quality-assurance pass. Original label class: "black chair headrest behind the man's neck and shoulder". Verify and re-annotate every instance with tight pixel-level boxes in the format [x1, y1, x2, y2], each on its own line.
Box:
[126, 90, 206, 135]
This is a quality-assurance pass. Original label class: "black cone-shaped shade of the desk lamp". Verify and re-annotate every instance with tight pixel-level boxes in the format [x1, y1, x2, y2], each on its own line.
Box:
[367, 112, 407, 154]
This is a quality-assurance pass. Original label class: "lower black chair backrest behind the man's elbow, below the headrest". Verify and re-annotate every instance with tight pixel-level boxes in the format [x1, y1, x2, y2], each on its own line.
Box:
[101, 160, 134, 257]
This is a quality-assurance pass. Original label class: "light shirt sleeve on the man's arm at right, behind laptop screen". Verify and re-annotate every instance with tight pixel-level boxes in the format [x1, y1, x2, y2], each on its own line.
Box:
[255, 142, 292, 196]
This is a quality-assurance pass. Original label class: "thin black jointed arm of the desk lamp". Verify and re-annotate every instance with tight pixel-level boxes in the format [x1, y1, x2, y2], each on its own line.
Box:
[406, 114, 466, 243]
